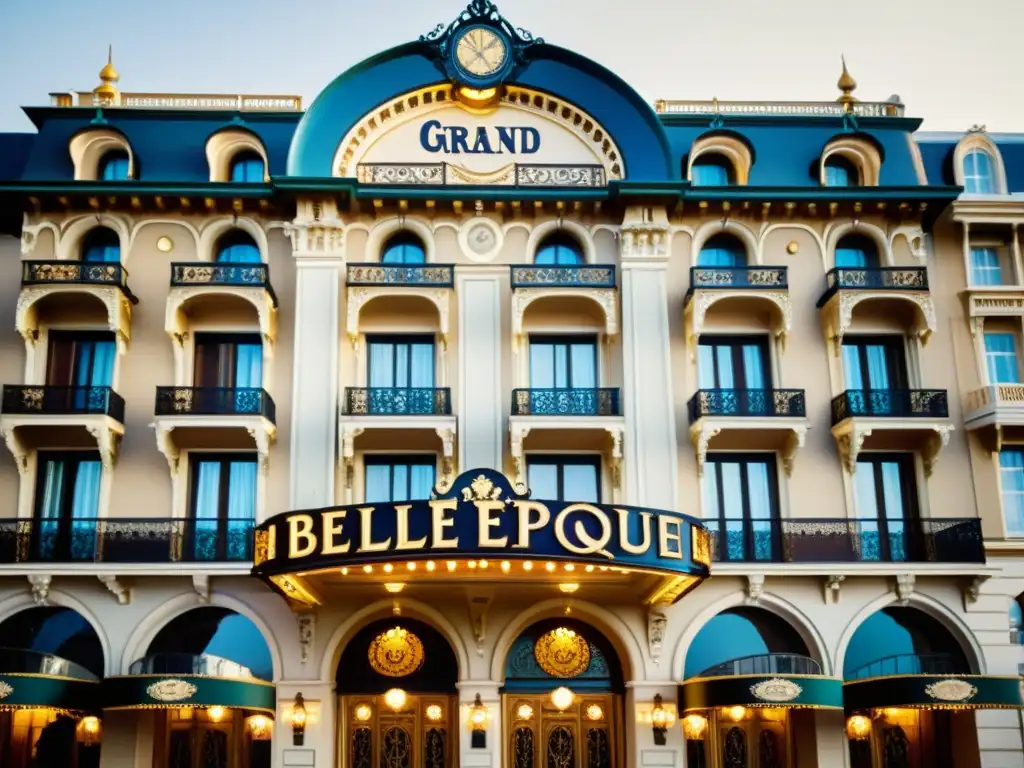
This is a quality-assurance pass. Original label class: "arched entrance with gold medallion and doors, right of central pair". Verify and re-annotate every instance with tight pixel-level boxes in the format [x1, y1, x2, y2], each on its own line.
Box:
[502, 618, 625, 768]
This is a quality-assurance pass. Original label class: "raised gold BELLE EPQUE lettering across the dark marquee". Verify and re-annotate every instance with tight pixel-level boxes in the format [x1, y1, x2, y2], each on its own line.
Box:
[273, 499, 689, 562]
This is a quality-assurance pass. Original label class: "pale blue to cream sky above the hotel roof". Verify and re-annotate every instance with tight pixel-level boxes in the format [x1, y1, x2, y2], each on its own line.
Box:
[0, 0, 1024, 133]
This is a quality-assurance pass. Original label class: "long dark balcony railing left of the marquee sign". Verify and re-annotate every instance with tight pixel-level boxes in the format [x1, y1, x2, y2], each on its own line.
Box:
[0, 517, 253, 563]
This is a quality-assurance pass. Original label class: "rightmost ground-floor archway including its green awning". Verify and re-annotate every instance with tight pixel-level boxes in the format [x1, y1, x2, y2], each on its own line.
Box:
[843, 605, 987, 768]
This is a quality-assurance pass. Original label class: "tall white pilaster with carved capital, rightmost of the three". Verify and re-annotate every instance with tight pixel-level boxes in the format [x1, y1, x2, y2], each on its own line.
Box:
[620, 207, 678, 509]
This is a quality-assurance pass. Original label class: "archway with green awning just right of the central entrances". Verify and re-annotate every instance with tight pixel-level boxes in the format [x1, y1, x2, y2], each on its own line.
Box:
[680, 606, 843, 768]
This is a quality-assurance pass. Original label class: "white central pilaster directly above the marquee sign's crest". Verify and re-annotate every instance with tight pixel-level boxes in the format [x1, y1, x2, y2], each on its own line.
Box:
[456, 266, 509, 475]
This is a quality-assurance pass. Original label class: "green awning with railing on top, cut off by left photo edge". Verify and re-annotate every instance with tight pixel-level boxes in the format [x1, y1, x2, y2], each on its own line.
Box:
[0, 648, 100, 713]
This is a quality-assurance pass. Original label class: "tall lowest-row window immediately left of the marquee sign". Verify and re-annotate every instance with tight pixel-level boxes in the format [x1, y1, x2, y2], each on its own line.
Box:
[186, 454, 256, 562]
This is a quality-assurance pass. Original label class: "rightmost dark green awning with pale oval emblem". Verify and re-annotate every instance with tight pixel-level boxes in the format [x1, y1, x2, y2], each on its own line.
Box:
[843, 675, 1024, 712]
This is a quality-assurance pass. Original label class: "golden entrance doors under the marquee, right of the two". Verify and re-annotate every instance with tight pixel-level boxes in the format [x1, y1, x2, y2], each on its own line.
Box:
[503, 693, 625, 768]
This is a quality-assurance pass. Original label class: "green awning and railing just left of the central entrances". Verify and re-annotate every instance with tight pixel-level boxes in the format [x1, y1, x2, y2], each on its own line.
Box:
[102, 654, 276, 715]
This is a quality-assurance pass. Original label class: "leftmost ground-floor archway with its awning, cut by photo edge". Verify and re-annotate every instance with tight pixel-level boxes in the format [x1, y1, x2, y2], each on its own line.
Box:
[0, 606, 103, 768]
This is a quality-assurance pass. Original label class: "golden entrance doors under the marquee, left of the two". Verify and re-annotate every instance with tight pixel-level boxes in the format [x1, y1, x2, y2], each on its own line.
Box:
[339, 693, 459, 768]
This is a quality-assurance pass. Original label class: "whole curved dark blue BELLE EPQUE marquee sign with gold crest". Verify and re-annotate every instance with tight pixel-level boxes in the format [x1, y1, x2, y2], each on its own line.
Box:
[253, 469, 711, 588]
